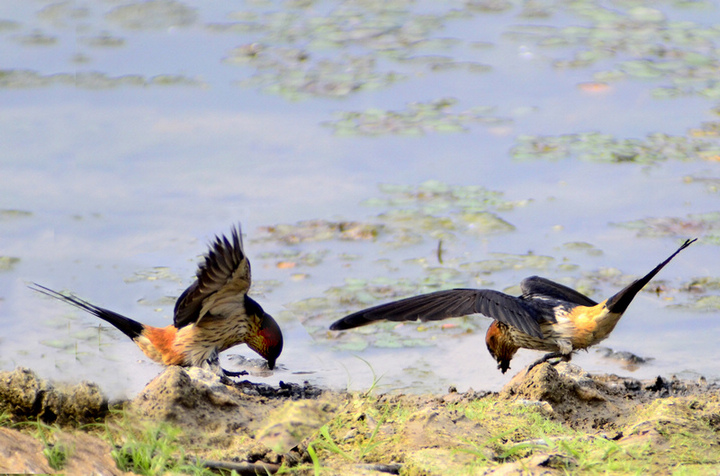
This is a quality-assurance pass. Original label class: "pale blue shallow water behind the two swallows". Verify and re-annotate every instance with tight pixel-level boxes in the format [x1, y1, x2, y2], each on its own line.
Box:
[0, 2, 720, 395]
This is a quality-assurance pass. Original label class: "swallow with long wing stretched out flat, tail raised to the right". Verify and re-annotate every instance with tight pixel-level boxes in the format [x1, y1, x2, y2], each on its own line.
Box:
[330, 238, 697, 373]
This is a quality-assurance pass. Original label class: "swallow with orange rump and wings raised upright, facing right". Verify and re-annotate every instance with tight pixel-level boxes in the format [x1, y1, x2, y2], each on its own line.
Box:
[30, 226, 283, 377]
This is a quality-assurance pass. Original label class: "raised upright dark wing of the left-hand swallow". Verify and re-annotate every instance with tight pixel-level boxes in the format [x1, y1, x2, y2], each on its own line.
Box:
[174, 225, 250, 328]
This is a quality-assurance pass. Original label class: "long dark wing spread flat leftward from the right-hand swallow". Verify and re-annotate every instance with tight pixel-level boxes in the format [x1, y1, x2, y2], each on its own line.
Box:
[330, 289, 543, 338]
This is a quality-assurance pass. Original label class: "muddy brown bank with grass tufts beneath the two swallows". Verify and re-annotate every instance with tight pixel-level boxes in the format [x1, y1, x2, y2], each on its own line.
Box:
[0, 363, 720, 474]
